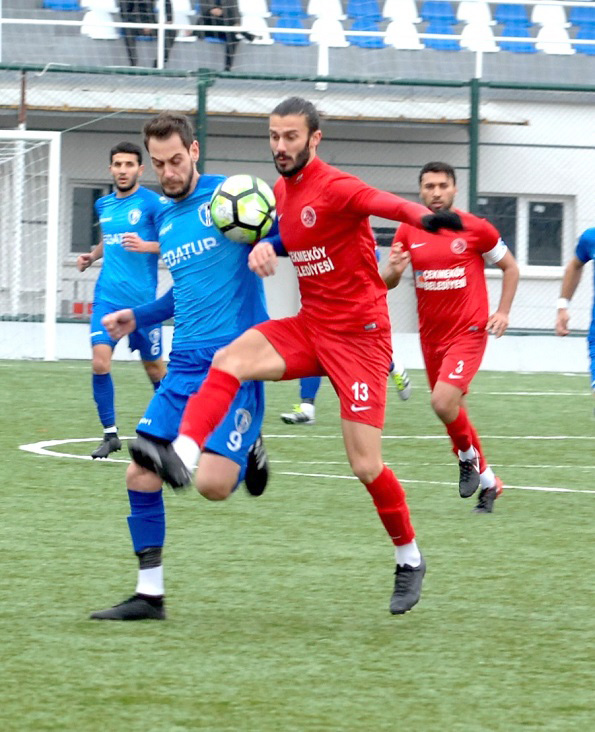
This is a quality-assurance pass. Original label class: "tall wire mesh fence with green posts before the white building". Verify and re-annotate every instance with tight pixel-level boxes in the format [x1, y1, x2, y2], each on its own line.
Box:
[0, 34, 595, 352]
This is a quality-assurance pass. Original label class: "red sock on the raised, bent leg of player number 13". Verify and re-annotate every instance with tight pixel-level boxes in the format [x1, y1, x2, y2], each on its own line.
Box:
[180, 368, 241, 448]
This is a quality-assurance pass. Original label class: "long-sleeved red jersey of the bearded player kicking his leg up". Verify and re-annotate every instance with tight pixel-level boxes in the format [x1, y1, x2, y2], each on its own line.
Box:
[275, 158, 430, 331]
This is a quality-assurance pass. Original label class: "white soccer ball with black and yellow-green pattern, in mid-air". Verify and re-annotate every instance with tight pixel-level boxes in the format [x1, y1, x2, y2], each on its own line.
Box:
[211, 175, 277, 244]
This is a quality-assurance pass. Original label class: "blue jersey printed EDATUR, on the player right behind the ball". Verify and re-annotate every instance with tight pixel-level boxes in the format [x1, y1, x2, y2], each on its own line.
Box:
[157, 175, 268, 351]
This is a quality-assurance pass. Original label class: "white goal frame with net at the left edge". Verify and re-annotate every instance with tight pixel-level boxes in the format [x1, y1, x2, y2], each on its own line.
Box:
[0, 130, 61, 361]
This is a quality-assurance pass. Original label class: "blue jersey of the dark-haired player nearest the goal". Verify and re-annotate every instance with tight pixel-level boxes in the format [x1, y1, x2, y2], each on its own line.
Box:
[95, 186, 164, 310]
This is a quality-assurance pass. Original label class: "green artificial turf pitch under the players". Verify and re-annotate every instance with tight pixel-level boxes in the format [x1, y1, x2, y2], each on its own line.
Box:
[0, 361, 595, 732]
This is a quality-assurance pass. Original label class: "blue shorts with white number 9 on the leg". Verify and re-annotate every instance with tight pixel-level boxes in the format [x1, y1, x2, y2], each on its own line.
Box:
[136, 346, 264, 480]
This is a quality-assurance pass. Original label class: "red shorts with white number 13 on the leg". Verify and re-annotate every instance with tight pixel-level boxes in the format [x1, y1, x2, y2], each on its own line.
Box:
[254, 313, 392, 428]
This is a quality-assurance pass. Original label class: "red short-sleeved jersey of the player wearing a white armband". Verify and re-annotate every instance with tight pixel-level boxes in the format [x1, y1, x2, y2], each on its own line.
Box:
[393, 210, 507, 343]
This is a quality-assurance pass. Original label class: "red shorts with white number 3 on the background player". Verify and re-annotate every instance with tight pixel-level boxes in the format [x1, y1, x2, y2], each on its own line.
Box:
[421, 330, 488, 394]
